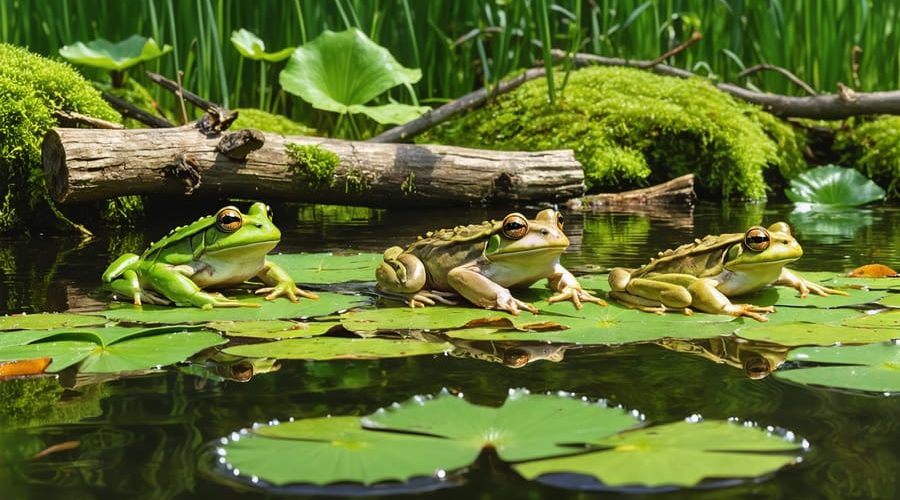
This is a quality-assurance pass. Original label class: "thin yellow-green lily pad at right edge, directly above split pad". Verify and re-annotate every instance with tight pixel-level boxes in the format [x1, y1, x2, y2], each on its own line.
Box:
[737, 323, 900, 346]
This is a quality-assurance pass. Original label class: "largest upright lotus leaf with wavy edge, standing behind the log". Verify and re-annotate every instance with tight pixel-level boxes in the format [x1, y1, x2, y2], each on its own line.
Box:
[279, 28, 428, 124]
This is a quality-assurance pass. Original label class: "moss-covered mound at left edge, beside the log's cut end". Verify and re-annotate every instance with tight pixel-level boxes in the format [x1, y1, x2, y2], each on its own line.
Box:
[0, 44, 119, 233]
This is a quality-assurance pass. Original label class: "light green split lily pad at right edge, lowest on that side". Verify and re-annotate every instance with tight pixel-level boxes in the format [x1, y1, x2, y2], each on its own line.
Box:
[775, 342, 900, 393]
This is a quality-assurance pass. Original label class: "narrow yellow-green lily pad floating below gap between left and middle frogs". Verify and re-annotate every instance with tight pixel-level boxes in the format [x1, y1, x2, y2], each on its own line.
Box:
[224, 337, 453, 360]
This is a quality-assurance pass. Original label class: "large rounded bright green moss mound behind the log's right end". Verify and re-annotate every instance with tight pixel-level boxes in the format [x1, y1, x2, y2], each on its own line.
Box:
[422, 67, 805, 199]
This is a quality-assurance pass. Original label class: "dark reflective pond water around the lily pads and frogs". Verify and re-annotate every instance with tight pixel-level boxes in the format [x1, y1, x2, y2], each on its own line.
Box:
[0, 204, 900, 499]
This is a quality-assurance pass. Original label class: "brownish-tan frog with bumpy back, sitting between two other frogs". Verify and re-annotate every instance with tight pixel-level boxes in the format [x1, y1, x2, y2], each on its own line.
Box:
[375, 208, 607, 315]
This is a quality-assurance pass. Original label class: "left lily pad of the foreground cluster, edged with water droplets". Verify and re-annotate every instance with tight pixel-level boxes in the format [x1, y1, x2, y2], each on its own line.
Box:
[218, 417, 473, 486]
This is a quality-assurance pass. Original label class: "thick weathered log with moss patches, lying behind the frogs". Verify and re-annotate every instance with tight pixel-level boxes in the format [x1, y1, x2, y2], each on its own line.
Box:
[42, 127, 584, 207]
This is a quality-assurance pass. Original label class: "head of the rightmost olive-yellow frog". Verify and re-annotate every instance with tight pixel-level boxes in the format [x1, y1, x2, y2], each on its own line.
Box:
[725, 222, 803, 272]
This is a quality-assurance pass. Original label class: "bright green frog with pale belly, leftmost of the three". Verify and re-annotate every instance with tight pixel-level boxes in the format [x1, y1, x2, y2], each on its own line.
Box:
[102, 202, 318, 309]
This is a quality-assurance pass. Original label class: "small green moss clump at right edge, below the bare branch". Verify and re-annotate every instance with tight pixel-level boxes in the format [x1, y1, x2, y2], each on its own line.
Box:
[834, 116, 900, 199]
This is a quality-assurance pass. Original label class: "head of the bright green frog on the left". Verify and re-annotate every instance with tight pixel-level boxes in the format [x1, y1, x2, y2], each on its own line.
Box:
[204, 202, 281, 259]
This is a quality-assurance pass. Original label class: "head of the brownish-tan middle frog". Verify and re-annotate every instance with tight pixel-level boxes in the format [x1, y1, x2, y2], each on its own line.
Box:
[484, 208, 569, 260]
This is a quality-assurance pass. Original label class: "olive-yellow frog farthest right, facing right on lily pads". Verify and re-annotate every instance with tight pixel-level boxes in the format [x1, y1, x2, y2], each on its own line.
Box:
[609, 222, 847, 322]
